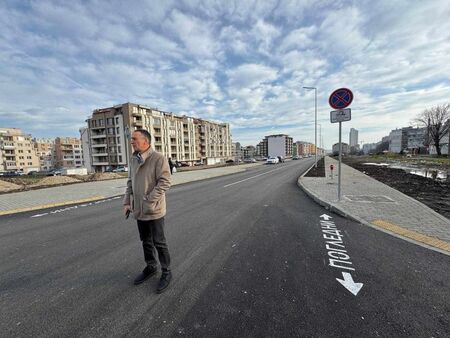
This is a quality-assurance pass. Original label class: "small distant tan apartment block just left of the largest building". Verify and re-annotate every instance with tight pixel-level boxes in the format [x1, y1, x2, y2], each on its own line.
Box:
[54, 137, 83, 168]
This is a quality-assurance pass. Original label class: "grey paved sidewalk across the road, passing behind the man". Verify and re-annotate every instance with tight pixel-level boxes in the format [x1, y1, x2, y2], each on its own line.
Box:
[0, 162, 261, 216]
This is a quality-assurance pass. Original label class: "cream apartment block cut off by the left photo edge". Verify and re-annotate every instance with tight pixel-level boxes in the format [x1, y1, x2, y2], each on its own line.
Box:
[0, 128, 40, 173]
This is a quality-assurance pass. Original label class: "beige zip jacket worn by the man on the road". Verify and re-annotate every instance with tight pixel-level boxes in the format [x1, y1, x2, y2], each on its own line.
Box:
[123, 148, 170, 221]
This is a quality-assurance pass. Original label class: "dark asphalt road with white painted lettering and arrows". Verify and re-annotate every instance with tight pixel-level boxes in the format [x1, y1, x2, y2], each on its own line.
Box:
[0, 159, 450, 337]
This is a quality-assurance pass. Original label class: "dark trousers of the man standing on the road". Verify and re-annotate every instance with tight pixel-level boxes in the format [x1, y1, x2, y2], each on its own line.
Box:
[137, 217, 170, 272]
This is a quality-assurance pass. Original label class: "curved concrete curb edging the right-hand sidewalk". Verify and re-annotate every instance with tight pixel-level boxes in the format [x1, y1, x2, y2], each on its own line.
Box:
[297, 172, 450, 256]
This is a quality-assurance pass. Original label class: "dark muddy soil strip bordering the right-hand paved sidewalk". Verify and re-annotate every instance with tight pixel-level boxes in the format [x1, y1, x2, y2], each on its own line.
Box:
[343, 157, 450, 219]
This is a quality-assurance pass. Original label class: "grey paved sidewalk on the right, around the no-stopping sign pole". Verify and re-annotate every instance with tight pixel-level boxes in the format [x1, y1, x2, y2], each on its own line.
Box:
[298, 157, 450, 255]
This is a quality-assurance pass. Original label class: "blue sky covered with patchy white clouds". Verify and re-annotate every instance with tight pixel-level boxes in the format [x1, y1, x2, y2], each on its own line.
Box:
[0, 0, 450, 148]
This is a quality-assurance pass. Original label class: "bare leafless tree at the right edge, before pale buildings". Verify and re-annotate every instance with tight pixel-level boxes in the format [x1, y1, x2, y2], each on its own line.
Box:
[415, 104, 450, 156]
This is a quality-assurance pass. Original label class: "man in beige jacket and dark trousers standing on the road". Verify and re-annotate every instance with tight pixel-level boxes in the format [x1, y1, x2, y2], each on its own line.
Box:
[123, 129, 172, 293]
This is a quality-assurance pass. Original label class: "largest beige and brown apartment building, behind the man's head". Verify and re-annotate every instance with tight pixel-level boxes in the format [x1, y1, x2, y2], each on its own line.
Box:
[84, 103, 231, 171]
